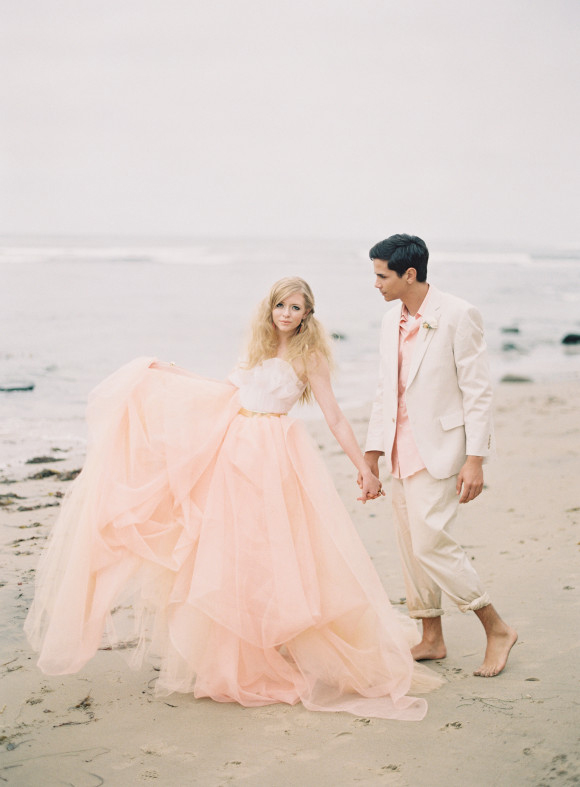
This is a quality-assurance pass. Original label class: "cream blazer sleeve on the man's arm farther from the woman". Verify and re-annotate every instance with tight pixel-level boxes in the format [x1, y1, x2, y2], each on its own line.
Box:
[453, 306, 495, 457]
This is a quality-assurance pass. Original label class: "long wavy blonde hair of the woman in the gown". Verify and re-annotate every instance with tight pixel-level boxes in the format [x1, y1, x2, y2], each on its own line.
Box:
[245, 276, 333, 403]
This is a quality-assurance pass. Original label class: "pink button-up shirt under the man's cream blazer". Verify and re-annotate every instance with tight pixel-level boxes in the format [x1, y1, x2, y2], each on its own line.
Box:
[391, 291, 429, 478]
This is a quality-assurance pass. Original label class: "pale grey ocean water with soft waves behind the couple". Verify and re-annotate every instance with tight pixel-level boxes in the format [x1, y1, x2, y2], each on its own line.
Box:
[0, 239, 580, 475]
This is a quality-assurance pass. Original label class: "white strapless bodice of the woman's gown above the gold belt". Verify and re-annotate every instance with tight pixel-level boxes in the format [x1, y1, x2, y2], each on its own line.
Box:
[229, 358, 306, 413]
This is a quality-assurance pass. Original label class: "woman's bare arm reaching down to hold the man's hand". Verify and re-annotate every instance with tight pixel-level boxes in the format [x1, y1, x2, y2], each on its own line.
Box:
[306, 353, 384, 503]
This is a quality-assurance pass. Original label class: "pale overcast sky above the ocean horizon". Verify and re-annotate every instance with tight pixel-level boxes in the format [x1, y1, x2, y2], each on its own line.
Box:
[0, 0, 580, 244]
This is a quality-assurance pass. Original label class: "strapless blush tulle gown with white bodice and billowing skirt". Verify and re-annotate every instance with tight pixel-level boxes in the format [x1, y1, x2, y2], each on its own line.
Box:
[25, 358, 441, 720]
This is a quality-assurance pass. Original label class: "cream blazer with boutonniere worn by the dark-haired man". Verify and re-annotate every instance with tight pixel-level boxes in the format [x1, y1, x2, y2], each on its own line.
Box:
[366, 286, 495, 478]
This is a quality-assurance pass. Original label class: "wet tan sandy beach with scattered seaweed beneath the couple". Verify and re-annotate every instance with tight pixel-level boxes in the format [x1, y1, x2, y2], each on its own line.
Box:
[0, 383, 580, 787]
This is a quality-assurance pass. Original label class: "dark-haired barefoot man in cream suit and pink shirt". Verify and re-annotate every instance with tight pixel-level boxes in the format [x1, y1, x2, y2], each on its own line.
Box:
[365, 235, 517, 677]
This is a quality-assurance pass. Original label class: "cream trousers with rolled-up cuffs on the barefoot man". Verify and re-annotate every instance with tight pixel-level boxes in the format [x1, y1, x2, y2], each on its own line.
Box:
[392, 470, 491, 618]
